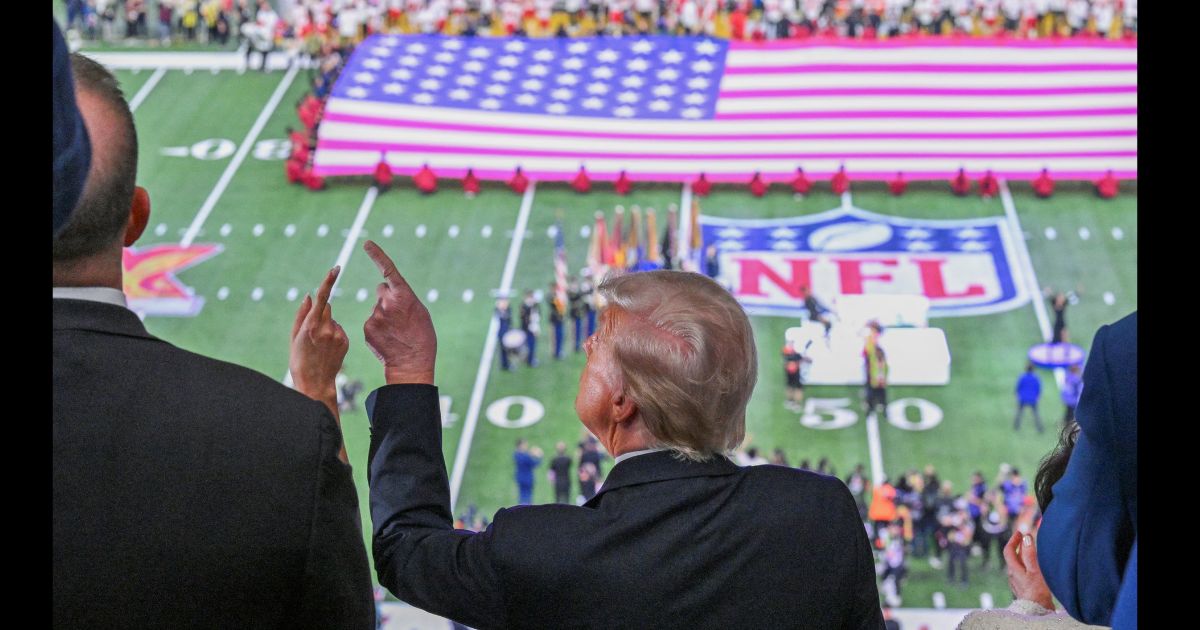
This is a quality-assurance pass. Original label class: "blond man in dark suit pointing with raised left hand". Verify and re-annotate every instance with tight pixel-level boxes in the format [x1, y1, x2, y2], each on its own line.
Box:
[364, 246, 883, 629]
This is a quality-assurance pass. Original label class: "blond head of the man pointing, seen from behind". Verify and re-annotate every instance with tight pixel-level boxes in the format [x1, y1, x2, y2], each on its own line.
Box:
[575, 271, 758, 460]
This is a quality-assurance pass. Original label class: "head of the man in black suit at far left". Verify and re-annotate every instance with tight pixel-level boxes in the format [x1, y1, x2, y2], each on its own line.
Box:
[53, 54, 150, 287]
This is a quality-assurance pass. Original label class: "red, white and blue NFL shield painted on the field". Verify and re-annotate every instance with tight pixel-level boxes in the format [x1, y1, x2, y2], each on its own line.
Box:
[701, 206, 1030, 317]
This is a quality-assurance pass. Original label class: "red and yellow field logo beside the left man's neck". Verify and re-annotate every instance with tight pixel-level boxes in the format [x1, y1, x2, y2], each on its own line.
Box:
[121, 245, 222, 317]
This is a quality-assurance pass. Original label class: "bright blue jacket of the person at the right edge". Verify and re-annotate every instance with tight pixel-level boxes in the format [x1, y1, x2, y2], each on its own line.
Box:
[1038, 312, 1138, 629]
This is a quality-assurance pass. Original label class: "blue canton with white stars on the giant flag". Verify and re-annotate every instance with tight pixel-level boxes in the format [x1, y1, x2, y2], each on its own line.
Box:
[334, 35, 729, 119]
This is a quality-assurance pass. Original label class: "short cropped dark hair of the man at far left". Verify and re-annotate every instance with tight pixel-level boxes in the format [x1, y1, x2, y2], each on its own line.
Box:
[53, 53, 138, 262]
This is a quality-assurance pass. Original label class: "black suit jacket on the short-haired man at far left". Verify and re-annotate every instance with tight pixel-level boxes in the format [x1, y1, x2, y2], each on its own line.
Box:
[53, 299, 374, 629]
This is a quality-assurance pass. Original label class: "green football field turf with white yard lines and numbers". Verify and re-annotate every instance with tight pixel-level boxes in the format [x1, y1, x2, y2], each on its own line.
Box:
[110, 70, 1138, 607]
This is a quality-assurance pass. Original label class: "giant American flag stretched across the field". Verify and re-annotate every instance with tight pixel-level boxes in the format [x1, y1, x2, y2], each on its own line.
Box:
[314, 35, 1138, 182]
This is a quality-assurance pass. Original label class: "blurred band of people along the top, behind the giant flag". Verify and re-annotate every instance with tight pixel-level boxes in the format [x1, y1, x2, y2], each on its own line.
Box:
[65, 0, 1138, 46]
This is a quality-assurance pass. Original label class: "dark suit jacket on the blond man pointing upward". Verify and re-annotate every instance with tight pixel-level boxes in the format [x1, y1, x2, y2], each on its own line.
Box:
[367, 385, 883, 629]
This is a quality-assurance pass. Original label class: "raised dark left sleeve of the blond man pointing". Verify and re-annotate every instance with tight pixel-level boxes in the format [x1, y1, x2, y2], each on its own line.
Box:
[366, 385, 506, 628]
